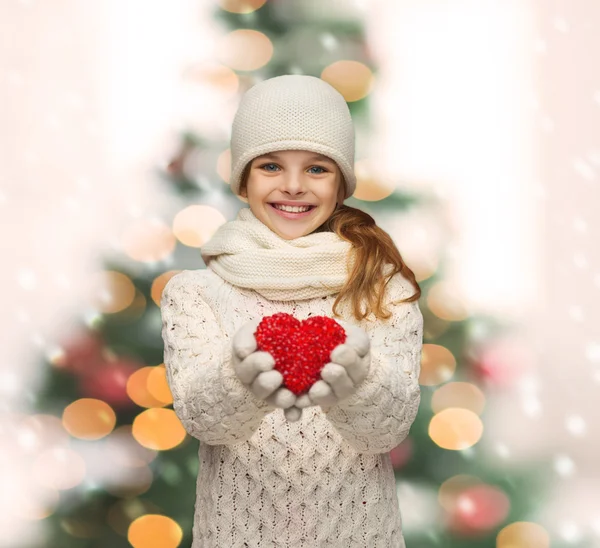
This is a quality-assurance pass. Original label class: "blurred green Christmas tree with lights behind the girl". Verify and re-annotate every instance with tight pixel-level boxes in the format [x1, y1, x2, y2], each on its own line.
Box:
[24, 0, 568, 548]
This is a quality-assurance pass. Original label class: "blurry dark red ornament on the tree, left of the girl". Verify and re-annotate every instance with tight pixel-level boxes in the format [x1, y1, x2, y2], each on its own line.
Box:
[80, 358, 143, 408]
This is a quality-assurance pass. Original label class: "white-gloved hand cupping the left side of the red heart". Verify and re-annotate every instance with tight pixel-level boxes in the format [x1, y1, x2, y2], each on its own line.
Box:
[232, 318, 299, 408]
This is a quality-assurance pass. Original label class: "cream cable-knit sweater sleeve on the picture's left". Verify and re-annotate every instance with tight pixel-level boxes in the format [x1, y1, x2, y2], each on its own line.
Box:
[161, 270, 275, 445]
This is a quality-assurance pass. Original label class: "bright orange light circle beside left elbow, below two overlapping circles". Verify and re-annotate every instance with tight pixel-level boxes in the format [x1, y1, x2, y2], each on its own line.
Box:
[133, 407, 186, 451]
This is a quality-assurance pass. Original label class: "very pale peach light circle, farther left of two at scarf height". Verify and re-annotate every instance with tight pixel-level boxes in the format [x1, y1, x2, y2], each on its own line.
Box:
[121, 219, 176, 262]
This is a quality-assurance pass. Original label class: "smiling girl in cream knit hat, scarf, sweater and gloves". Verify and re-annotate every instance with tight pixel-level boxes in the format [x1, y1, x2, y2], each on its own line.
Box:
[161, 75, 423, 548]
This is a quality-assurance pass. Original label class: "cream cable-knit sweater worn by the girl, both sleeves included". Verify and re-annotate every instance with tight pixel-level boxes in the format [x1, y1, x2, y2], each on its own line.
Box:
[161, 268, 423, 548]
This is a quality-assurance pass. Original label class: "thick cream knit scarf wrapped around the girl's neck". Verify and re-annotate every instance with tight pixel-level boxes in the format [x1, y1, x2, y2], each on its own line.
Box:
[201, 208, 352, 301]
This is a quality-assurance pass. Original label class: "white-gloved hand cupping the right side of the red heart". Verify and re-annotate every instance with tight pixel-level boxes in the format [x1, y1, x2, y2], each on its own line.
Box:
[310, 320, 371, 407]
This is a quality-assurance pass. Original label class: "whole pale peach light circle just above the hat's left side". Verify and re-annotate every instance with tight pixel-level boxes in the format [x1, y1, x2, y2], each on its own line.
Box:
[217, 29, 273, 71]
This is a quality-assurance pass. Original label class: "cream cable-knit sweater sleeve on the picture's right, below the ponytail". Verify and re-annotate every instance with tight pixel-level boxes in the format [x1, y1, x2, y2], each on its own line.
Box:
[323, 275, 423, 454]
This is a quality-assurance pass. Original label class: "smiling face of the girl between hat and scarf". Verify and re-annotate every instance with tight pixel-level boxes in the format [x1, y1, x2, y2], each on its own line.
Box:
[240, 150, 344, 240]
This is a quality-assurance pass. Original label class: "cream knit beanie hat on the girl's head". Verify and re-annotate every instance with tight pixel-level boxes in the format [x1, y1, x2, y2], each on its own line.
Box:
[230, 74, 356, 199]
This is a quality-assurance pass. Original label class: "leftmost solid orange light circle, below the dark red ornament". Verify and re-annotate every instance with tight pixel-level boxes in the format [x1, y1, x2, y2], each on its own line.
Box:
[62, 398, 117, 440]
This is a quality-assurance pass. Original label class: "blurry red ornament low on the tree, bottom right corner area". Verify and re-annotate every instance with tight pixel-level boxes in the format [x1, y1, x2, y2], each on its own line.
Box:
[449, 483, 510, 537]
